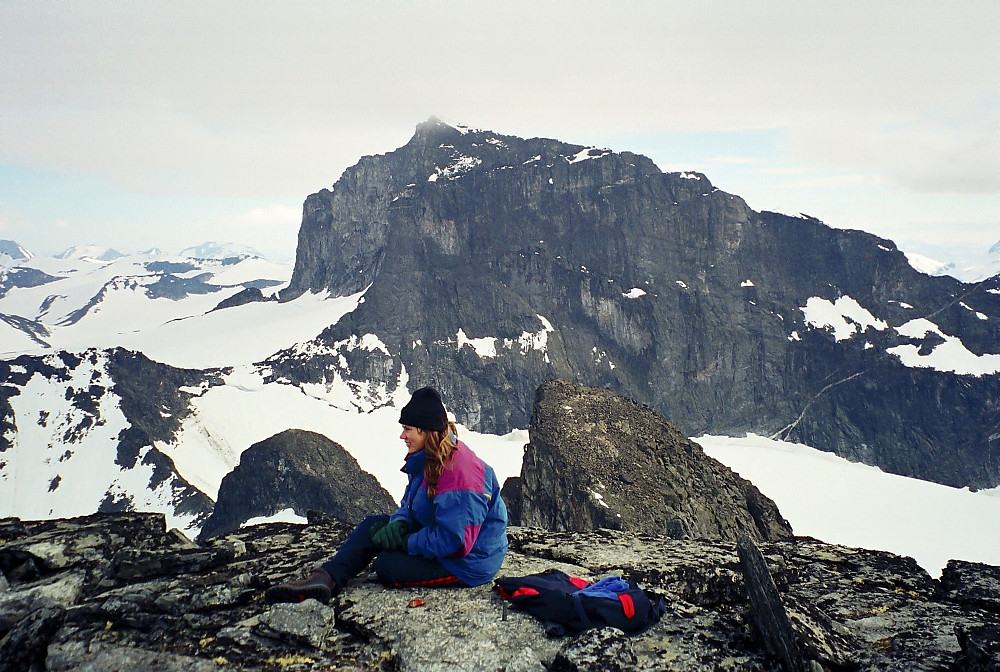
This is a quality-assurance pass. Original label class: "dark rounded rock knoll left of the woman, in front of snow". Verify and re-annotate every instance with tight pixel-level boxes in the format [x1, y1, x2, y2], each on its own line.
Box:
[200, 429, 396, 538]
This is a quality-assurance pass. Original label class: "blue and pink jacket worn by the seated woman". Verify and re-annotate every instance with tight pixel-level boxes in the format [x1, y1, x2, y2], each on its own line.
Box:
[390, 441, 507, 586]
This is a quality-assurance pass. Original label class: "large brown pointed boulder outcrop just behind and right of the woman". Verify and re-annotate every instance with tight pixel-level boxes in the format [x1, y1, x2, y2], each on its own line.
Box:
[503, 380, 792, 541]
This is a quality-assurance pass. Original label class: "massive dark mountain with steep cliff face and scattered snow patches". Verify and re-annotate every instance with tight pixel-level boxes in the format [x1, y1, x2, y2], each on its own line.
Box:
[267, 119, 1000, 487]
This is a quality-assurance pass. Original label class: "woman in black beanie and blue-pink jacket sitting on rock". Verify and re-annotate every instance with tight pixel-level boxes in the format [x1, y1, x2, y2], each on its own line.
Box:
[265, 387, 507, 603]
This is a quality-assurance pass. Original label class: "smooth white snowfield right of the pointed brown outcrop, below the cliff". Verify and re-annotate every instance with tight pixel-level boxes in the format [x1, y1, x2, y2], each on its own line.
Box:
[694, 435, 1000, 577]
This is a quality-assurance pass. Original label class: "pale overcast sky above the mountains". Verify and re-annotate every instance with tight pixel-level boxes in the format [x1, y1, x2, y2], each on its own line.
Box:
[0, 0, 1000, 259]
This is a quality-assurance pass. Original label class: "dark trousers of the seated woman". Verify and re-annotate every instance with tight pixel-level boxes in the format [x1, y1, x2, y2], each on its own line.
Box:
[320, 515, 461, 588]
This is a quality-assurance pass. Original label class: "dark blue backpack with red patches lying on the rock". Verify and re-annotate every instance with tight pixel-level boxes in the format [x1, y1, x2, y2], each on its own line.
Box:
[494, 569, 667, 637]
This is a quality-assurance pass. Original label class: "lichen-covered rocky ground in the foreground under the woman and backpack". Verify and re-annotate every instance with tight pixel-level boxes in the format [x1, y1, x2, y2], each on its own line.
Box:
[0, 513, 1000, 672]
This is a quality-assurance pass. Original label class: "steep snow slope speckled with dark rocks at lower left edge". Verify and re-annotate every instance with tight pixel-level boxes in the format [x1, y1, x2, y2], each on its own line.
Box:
[0, 350, 210, 531]
